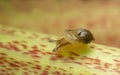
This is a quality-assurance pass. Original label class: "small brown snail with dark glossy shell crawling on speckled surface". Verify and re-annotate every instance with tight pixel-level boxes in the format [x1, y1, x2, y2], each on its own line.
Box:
[50, 28, 95, 52]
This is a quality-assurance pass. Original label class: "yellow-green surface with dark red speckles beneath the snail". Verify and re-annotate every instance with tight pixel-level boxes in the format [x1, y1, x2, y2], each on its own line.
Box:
[0, 26, 120, 75]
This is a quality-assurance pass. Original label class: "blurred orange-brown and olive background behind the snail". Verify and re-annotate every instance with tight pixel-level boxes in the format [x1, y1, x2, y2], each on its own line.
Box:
[0, 0, 120, 48]
